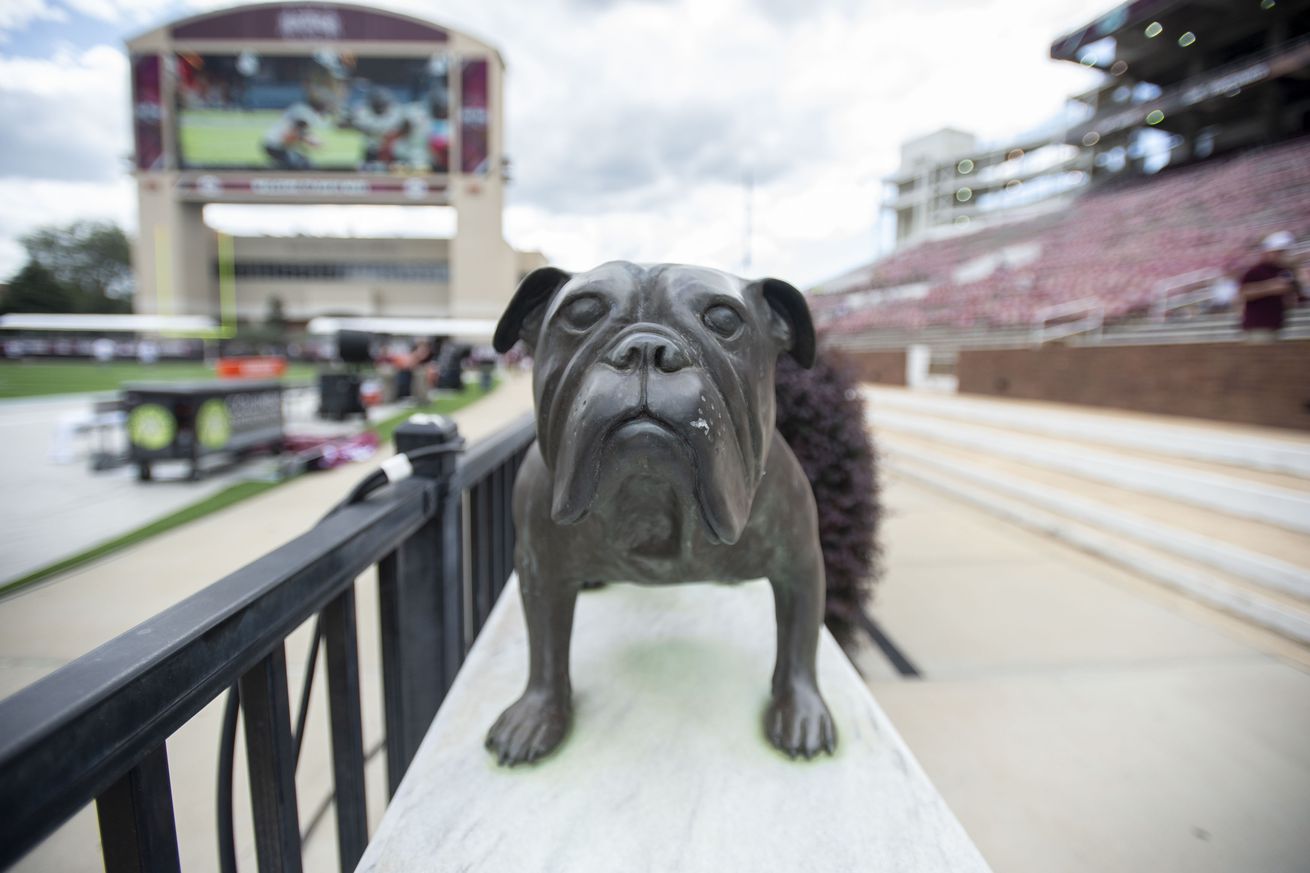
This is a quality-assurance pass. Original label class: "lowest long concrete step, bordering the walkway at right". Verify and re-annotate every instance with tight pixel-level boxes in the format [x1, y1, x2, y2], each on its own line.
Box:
[880, 437, 1310, 645]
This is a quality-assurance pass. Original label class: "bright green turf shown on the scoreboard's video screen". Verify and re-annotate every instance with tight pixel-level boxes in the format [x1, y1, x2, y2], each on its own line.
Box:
[178, 109, 364, 169]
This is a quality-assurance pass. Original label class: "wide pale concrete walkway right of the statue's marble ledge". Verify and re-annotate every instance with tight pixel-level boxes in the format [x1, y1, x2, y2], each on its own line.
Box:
[859, 477, 1310, 873]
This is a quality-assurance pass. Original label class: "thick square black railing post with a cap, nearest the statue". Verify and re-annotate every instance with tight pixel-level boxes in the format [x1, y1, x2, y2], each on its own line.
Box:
[377, 416, 464, 794]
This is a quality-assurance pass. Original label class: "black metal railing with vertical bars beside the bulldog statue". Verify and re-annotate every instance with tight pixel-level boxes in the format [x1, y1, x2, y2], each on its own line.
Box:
[0, 418, 533, 873]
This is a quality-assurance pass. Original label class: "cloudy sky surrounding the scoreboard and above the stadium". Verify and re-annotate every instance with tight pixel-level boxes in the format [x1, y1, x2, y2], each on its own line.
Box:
[0, 0, 1114, 284]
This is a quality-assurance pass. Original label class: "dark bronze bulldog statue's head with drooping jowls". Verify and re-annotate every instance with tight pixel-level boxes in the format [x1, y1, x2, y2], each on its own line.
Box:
[495, 261, 815, 544]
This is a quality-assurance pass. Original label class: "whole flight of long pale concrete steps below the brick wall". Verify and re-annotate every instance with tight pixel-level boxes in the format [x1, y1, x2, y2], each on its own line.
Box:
[866, 387, 1310, 645]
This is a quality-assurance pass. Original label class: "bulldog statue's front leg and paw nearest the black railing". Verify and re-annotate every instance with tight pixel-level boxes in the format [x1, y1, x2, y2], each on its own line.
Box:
[486, 563, 582, 767]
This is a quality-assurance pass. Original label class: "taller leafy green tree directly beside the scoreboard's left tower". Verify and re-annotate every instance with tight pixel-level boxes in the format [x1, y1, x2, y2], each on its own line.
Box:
[21, 222, 132, 313]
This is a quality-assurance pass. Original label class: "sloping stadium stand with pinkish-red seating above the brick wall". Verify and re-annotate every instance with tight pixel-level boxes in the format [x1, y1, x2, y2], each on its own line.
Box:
[810, 138, 1310, 335]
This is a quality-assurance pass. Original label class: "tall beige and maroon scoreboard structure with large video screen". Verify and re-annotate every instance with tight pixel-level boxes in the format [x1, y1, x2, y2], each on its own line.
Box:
[127, 3, 517, 325]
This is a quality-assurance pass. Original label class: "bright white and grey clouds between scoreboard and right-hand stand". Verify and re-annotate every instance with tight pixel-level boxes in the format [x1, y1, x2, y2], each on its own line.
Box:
[492, 0, 1100, 283]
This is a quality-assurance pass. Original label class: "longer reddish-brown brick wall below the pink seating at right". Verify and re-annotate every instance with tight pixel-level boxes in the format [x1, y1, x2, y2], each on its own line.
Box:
[956, 341, 1310, 430]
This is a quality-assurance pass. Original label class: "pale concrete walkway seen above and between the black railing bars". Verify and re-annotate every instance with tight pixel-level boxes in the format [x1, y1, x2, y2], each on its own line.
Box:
[0, 376, 532, 873]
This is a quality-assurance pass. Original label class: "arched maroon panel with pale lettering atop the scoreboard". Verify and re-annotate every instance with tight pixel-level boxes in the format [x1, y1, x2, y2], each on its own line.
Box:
[173, 3, 449, 42]
